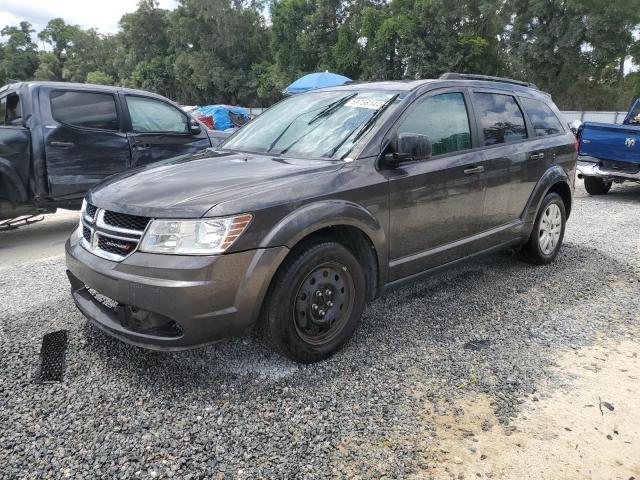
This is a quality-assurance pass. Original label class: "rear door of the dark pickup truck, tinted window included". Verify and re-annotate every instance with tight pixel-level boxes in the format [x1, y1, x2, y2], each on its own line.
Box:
[40, 88, 130, 198]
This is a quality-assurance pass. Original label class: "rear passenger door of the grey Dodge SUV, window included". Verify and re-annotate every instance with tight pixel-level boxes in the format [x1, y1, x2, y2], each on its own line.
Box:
[472, 90, 532, 231]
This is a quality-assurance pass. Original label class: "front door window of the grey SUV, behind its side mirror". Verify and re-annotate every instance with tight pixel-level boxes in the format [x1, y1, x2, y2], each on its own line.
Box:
[398, 92, 471, 155]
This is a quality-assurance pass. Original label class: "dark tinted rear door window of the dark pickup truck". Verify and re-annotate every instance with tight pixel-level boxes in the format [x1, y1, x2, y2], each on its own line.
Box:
[51, 90, 119, 130]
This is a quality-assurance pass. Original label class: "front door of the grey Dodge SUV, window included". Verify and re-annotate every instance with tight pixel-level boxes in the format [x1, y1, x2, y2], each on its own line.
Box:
[389, 90, 485, 281]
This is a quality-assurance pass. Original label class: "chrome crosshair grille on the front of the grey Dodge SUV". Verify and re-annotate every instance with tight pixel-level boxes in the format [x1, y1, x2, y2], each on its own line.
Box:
[81, 205, 151, 261]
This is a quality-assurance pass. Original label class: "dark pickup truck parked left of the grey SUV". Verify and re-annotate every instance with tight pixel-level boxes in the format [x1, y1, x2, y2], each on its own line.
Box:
[0, 82, 217, 225]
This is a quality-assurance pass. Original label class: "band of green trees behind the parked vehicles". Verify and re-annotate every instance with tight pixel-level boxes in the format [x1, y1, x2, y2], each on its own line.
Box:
[0, 0, 640, 109]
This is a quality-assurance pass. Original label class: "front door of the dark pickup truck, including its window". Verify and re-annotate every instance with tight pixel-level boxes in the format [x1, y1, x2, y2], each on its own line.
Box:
[125, 95, 211, 167]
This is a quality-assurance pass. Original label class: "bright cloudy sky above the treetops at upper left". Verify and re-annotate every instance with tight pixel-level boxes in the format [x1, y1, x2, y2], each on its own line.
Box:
[0, 0, 178, 39]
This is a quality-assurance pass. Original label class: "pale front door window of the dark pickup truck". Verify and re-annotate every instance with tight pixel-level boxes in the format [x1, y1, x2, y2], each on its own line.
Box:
[127, 96, 189, 133]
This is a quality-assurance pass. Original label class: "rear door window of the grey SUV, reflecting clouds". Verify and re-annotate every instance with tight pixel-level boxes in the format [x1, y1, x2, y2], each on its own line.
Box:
[473, 93, 527, 146]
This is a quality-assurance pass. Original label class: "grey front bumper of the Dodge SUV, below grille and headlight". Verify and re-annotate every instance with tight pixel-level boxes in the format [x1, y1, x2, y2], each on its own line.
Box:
[65, 234, 288, 350]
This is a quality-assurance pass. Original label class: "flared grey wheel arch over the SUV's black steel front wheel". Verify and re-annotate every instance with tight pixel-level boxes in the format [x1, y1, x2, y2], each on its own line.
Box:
[259, 200, 387, 278]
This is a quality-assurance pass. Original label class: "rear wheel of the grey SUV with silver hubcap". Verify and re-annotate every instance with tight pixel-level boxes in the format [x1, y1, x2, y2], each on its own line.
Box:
[520, 193, 567, 265]
